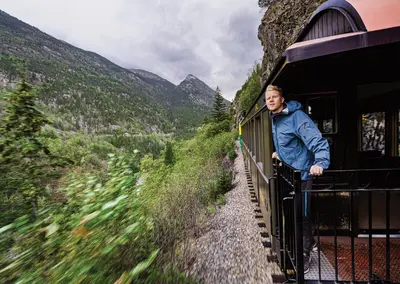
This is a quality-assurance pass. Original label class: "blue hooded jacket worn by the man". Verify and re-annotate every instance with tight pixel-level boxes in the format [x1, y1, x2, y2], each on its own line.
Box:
[270, 101, 330, 180]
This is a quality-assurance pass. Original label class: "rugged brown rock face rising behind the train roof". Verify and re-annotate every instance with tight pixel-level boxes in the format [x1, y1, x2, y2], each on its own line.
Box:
[258, 0, 325, 84]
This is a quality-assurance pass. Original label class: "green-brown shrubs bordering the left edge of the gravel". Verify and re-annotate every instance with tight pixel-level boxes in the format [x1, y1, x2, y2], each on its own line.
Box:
[141, 132, 234, 272]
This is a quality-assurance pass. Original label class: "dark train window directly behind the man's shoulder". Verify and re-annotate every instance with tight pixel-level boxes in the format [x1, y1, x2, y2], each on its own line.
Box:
[307, 96, 337, 134]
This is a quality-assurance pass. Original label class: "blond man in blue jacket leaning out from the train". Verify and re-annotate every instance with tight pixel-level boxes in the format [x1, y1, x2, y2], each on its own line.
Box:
[265, 85, 330, 273]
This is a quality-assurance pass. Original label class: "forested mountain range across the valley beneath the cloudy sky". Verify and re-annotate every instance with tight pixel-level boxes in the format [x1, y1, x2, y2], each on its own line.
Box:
[0, 10, 223, 134]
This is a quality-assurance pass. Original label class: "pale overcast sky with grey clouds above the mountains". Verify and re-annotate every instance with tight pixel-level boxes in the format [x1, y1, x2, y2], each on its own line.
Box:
[0, 0, 262, 100]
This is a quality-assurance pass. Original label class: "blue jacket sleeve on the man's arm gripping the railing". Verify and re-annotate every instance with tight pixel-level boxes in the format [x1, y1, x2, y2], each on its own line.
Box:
[295, 111, 330, 169]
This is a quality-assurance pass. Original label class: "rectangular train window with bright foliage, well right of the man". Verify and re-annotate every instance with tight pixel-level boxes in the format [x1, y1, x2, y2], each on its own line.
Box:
[361, 112, 385, 155]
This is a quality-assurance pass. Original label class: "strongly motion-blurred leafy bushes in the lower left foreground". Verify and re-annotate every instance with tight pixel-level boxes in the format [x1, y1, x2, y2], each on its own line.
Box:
[0, 155, 158, 283]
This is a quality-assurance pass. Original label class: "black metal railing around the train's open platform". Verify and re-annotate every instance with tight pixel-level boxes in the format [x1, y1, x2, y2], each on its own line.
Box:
[272, 159, 400, 283]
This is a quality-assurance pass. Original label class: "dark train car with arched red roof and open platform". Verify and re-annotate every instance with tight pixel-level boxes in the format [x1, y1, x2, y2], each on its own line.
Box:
[241, 0, 400, 283]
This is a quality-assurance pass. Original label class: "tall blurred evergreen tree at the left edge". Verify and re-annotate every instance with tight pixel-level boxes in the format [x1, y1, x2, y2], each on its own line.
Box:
[0, 74, 69, 215]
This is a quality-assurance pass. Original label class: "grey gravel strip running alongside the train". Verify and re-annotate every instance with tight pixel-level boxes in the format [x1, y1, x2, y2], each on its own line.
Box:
[190, 145, 279, 283]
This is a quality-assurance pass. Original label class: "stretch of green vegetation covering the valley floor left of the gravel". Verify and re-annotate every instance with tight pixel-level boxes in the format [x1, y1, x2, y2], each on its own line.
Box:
[0, 77, 235, 283]
